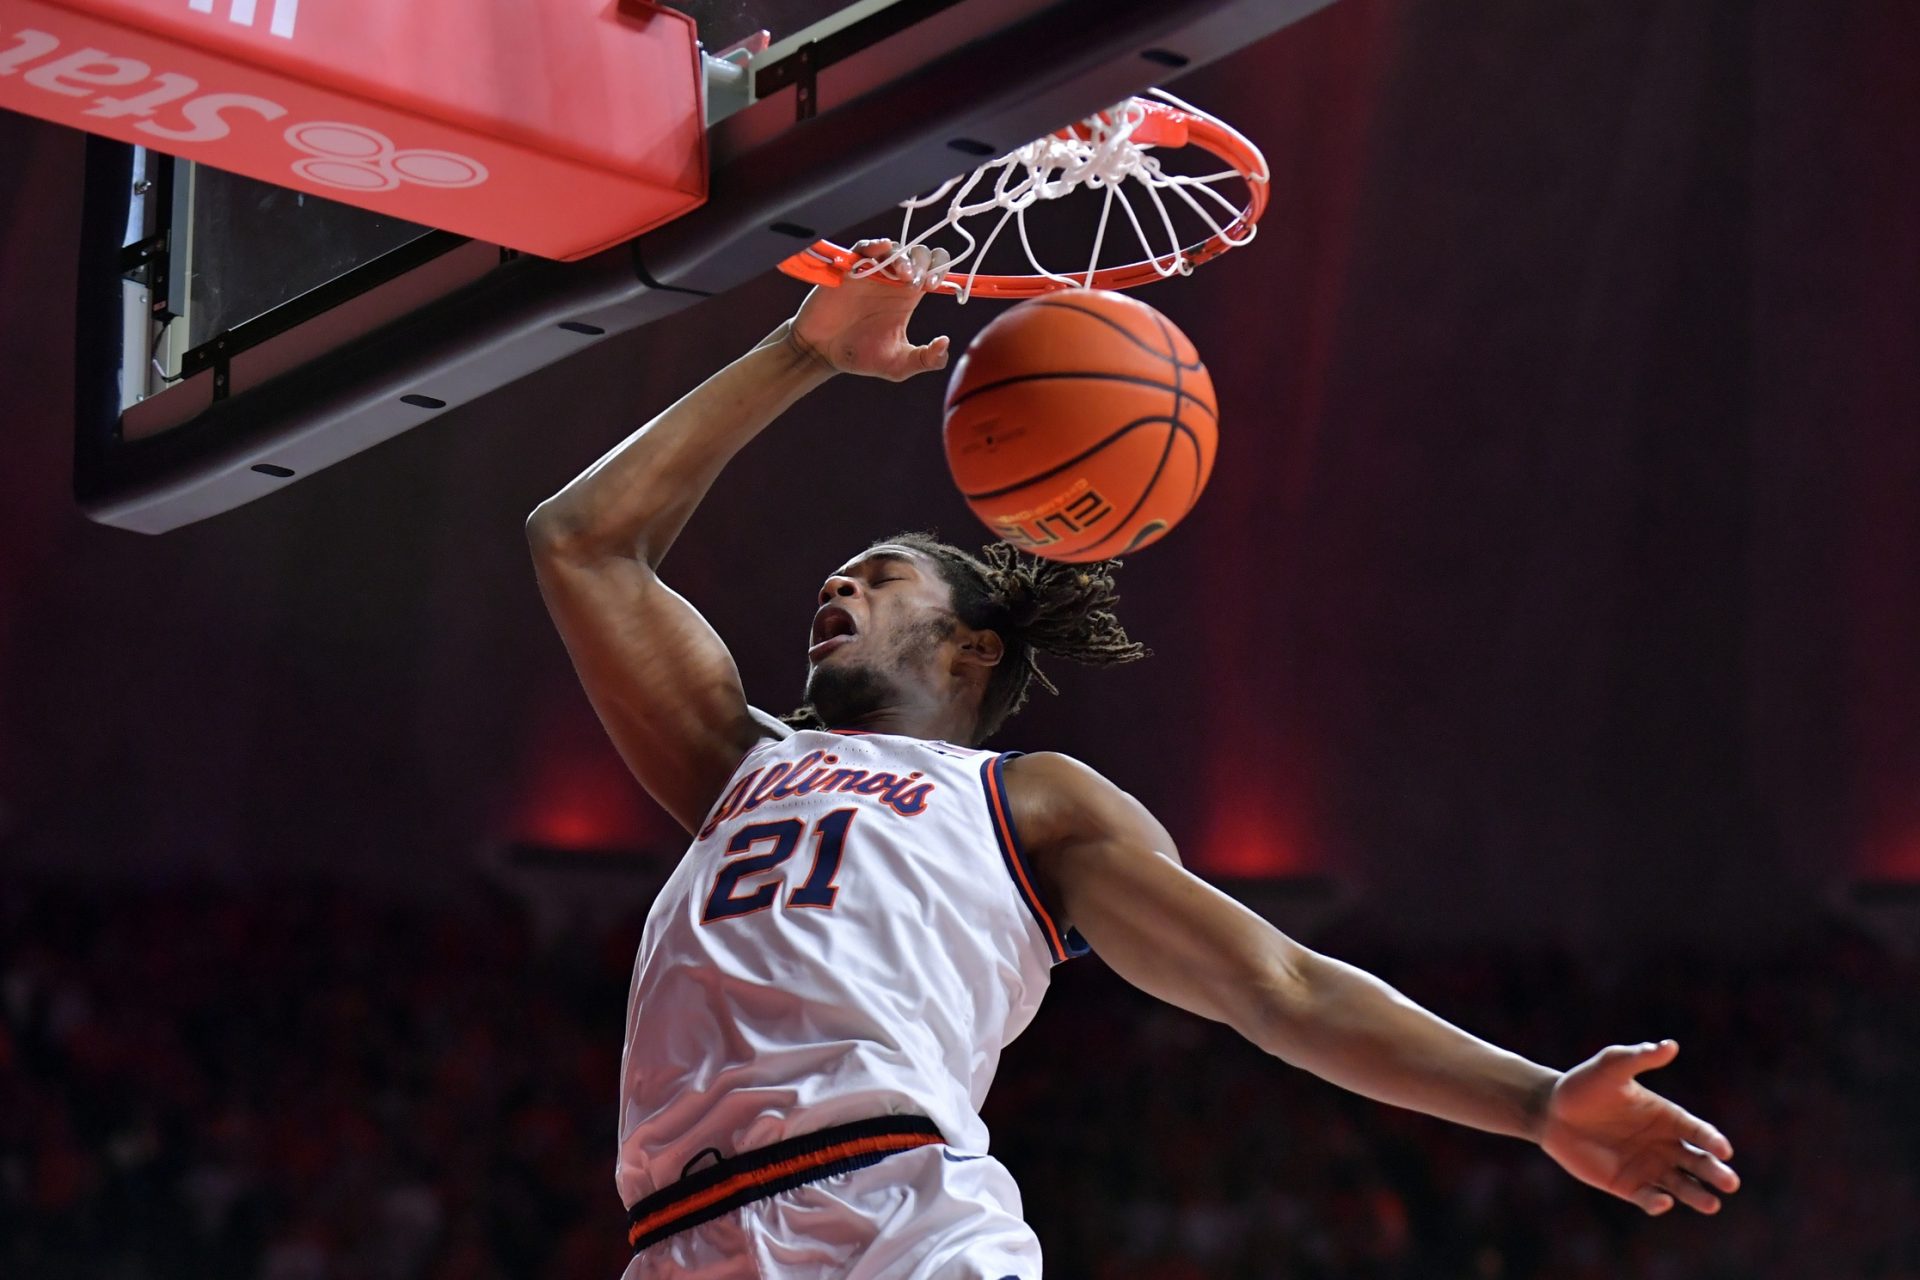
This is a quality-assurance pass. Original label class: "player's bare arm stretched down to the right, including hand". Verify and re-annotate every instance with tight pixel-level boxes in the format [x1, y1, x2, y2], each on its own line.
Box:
[1006, 754, 1740, 1215]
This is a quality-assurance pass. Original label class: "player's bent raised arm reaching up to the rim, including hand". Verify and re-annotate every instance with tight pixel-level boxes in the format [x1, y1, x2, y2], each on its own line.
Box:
[526, 245, 947, 831]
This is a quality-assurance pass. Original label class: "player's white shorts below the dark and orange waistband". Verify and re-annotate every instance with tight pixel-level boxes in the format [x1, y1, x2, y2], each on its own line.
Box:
[622, 1146, 1041, 1280]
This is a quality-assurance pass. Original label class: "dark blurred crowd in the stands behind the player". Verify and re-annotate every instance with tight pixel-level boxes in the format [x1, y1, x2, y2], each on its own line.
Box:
[0, 883, 1920, 1280]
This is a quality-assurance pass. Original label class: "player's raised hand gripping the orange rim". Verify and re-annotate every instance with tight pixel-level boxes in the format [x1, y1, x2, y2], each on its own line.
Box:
[787, 240, 947, 382]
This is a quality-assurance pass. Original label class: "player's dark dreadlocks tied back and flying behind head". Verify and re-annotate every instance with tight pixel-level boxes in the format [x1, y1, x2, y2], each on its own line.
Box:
[785, 533, 1150, 741]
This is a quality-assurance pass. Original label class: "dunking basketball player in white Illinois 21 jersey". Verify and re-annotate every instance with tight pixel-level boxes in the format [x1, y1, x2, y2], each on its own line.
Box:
[528, 246, 1740, 1280]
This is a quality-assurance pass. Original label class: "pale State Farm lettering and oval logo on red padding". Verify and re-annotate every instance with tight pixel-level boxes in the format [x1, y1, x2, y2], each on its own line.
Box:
[0, 25, 490, 192]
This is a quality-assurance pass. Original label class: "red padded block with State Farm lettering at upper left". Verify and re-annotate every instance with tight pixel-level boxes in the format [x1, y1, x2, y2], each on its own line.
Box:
[0, 0, 707, 259]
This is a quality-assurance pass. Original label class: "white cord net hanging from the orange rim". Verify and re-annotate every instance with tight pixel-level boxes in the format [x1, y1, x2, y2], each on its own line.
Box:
[849, 88, 1267, 301]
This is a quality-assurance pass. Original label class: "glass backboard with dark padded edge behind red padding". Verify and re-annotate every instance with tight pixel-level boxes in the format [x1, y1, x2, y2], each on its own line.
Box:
[75, 0, 1331, 533]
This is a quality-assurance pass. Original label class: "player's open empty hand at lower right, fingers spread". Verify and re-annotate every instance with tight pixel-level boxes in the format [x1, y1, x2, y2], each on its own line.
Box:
[1540, 1040, 1740, 1215]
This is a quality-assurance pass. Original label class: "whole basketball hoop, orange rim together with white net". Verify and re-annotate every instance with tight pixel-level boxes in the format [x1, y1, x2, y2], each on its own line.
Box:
[780, 88, 1267, 303]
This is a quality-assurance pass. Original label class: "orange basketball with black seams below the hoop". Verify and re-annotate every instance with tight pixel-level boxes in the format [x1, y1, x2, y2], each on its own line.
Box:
[947, 290, 1217, 560]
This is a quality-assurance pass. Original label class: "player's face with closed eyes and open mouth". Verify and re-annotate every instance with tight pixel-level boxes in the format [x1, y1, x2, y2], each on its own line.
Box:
[806, 543, 958, 723]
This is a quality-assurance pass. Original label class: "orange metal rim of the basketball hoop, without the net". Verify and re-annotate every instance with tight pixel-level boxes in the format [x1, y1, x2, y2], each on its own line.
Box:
[780, 98, 1267, 297]
